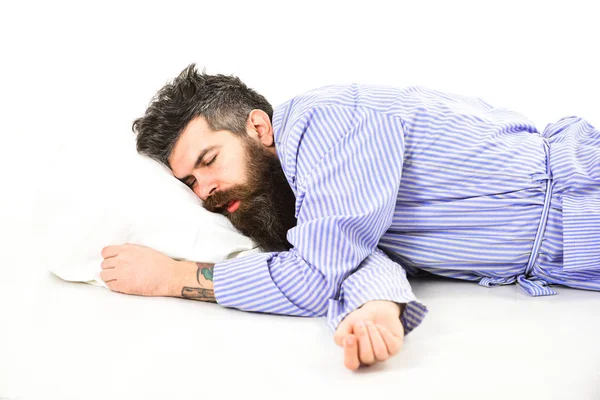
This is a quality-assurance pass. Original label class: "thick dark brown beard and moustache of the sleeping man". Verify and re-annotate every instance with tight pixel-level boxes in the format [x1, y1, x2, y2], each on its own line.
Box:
[204, 139, 297, 251]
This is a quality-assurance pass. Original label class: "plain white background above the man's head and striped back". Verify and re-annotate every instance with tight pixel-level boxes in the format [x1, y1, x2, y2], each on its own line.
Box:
[0, 0, 600, 398]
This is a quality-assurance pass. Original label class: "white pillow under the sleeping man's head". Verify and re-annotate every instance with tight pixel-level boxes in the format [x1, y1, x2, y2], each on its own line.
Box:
[34, 137, 258, 286]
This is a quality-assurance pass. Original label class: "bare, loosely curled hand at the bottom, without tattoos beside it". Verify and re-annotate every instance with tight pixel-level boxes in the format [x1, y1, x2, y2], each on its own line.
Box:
[334, 300, 404, 370]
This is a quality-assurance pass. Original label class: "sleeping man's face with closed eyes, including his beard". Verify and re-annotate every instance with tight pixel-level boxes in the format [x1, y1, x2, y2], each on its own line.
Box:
[169, 117, 296, 251]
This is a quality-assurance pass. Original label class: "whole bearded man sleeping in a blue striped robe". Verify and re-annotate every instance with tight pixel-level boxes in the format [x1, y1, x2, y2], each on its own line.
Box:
[101, 64, 600, 370]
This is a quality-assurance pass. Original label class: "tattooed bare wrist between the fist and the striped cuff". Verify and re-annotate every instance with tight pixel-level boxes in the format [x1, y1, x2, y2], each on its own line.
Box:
[169, 261, 217, 303]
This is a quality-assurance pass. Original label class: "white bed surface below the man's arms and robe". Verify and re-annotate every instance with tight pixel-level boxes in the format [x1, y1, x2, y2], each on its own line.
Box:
[0, 253, 600, 400]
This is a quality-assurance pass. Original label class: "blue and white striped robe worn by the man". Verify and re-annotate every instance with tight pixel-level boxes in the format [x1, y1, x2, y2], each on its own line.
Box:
[214, 84, 600, 334]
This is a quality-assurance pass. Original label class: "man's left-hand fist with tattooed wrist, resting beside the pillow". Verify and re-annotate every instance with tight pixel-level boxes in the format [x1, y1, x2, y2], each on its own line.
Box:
[100, 244, 216, 303]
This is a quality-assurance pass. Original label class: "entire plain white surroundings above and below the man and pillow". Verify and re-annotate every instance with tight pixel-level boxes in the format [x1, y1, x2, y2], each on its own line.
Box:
[0, 0, 600, 400]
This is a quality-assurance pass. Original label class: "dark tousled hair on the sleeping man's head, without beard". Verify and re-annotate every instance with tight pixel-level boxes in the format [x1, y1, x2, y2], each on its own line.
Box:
[132, 64, 273, 167]
